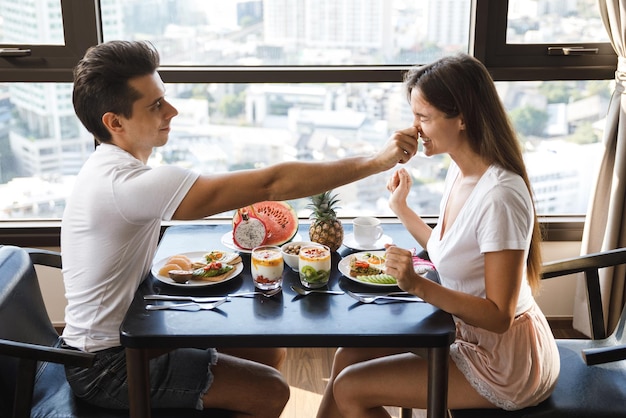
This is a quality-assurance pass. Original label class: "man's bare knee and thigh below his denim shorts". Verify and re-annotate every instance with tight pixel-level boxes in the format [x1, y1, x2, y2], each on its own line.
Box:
[203, 353, 289, 418]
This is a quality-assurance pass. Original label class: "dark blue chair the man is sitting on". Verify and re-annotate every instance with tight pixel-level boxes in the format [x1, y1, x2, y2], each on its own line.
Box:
[0, 245, 228, 418]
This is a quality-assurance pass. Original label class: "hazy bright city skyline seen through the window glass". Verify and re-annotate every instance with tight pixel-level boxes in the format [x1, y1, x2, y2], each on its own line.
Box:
[0, 0, 606, 219]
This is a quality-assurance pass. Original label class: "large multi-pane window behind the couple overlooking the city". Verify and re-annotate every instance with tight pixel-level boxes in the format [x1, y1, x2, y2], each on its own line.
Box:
[0, 0, 617, 229]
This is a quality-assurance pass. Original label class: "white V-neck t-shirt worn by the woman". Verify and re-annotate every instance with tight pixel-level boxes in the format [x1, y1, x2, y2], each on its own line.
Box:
[427, 164, 534, 315]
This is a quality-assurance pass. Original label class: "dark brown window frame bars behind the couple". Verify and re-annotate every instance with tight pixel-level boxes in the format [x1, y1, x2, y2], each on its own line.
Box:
[0, 0, 617, 246]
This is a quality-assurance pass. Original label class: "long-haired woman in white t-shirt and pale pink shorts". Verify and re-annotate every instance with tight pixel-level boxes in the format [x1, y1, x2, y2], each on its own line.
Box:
[318, 55, 559, 418]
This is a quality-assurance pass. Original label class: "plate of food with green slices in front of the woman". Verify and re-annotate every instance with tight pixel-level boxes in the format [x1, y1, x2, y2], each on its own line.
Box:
[338, 251, 398, 287]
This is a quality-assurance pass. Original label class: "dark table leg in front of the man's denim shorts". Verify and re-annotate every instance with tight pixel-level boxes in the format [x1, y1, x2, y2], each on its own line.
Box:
[126, 348, 151, 418]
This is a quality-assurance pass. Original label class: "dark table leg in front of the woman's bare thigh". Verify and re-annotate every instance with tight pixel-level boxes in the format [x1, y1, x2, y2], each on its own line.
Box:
[426, 346, 450, 418]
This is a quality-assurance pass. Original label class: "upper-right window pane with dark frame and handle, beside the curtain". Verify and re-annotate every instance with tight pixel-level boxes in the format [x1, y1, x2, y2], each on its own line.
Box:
[474, 0, 617, 80]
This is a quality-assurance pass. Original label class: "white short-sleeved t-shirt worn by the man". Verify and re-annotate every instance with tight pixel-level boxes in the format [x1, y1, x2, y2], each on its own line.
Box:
[61, 144, 198, 352]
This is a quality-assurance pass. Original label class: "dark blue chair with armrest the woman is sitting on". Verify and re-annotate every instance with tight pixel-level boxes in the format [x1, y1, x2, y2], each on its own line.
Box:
[450, 248, 626, 418]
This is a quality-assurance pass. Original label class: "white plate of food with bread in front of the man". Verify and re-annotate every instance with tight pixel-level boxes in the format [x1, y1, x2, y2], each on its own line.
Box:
[151, 250, 243, 287]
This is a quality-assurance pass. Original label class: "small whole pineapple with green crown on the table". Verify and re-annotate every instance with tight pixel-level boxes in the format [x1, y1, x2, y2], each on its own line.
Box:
[307, 190, 343, 251]
